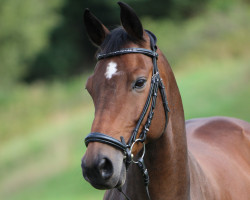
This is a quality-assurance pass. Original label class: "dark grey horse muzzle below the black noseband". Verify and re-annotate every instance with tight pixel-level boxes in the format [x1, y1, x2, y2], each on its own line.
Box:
[81, 143, 126, 189]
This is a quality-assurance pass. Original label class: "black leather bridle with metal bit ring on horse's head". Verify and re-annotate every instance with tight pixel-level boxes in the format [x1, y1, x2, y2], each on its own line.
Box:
[85, 31, 169, 199]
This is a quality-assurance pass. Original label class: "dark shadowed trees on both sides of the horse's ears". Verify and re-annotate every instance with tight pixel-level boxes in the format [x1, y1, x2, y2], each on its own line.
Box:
[26, 0, 211, 81]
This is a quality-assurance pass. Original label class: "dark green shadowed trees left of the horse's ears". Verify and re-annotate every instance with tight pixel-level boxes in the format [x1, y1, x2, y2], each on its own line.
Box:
[26, 0, 119, 81]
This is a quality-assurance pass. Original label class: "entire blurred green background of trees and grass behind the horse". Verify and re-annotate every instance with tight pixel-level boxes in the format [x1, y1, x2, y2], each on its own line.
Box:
[0, 0, 250, 200]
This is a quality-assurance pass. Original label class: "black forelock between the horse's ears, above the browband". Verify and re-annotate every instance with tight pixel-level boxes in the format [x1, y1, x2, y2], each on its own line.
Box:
[100, 26, 142, 53]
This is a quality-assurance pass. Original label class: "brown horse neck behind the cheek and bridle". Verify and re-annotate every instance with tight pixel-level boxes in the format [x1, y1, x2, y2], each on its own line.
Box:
[123, 53, 189, 200]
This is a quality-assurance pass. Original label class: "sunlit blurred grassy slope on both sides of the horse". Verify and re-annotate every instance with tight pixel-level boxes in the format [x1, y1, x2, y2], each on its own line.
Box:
[0, 1, 250, 200]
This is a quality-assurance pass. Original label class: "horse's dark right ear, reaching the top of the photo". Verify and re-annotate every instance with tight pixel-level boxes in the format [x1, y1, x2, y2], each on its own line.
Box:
[118, 1, 143, 40]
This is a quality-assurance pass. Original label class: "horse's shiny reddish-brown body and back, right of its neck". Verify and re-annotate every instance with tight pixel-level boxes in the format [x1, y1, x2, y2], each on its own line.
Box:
[186, 117, 250, 200]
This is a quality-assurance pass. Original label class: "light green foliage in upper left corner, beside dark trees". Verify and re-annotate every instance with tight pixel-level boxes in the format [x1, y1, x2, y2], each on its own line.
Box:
[0, 0, 61, 84]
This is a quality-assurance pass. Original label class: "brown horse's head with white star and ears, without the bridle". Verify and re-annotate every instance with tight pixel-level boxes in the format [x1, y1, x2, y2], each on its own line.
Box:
[82, 2, 168, 189]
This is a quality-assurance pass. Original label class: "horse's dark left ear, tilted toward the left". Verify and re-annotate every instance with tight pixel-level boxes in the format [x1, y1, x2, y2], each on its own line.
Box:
[84, 8, 109, 46]
